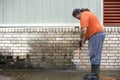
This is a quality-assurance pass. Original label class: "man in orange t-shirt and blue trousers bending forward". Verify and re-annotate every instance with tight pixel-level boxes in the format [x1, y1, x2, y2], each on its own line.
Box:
[72, 8, 105, 80]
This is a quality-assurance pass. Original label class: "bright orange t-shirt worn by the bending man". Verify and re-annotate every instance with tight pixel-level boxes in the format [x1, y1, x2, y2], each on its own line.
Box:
[80, 11, 104, 40]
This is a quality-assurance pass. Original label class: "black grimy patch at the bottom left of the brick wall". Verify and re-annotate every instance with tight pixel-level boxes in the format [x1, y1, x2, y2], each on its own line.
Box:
[0, 53, 31, 69]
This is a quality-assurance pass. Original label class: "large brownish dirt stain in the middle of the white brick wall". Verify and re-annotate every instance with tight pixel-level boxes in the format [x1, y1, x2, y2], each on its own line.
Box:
[27, 33, 78, 69]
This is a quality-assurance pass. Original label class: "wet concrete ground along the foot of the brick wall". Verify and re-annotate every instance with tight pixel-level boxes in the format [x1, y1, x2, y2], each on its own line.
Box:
[0, 70, 120, 80]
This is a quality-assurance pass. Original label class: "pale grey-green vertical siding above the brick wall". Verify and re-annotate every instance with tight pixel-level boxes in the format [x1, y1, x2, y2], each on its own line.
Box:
[0, 0, 101, 24]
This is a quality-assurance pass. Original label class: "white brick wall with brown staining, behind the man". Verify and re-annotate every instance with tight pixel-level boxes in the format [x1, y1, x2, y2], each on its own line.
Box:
[0, 27, 120, 70]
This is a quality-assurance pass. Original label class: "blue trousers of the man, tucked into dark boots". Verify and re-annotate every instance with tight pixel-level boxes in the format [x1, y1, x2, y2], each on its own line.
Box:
[89, 32, 105, 65]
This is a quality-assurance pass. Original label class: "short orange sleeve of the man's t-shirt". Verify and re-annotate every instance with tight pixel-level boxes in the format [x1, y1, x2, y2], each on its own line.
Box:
[80, 13, 89, 28]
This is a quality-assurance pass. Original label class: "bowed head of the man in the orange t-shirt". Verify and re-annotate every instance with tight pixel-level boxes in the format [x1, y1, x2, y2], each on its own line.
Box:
[72, 8, 90, 20]
